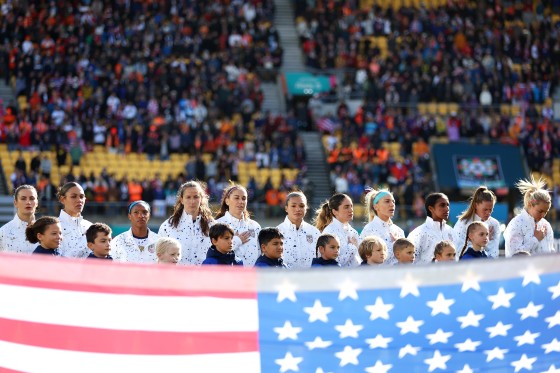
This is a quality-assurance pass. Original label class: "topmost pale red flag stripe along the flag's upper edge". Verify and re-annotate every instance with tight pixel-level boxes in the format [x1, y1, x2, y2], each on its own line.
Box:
[0, 253, 257, 299]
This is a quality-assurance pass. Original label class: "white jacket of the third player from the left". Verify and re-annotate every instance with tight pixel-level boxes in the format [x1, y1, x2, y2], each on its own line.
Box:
[110, 228, 159, 264]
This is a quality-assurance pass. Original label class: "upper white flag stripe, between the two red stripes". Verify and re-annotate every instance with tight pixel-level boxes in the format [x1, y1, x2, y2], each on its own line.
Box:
[0, 284, 259, 332]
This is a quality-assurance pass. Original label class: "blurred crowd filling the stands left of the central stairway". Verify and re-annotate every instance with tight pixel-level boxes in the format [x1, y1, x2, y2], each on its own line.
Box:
[0, 0, 312, 205]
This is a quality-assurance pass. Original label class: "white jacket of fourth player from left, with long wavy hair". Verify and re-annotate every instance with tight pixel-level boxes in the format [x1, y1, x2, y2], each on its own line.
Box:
[158, 211, 212, 265]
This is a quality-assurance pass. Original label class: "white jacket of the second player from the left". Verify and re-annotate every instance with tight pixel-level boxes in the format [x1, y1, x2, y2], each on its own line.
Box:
[58, 210, 91, 258]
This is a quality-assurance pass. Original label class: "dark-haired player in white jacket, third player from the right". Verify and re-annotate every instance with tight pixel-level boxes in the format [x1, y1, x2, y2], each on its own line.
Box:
[408, 193, 453, 263]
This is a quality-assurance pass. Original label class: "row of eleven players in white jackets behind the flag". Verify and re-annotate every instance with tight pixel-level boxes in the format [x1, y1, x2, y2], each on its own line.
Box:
[0, 178, 554, 268]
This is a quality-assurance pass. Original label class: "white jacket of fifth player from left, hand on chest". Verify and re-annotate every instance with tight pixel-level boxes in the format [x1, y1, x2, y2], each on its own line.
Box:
[216, 211, 261, 267]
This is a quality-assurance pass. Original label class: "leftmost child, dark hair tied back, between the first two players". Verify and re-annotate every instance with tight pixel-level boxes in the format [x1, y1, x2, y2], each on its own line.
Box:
[25, 216, 62, 256]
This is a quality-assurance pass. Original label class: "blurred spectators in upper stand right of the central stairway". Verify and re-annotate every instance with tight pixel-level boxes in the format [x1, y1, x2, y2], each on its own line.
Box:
[294, 0, 560, 106]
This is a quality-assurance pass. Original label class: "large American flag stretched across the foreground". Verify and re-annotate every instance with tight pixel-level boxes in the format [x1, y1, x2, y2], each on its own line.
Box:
[0, 251, 560, 373]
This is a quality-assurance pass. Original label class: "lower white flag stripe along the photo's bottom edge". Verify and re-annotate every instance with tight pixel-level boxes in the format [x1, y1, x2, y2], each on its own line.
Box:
[0, 341, 260, 373]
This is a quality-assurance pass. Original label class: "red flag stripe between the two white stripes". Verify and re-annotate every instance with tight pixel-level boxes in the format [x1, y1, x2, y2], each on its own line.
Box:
[0, 316, 258, 358]
